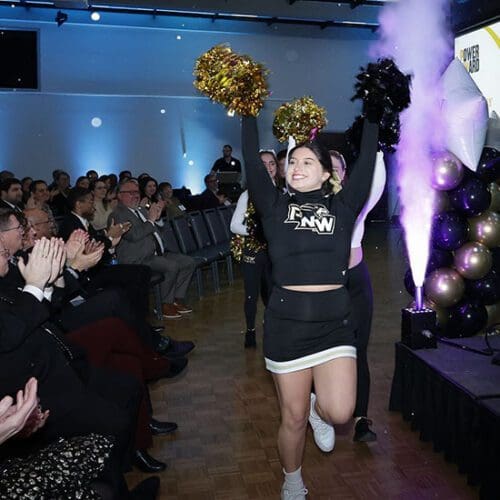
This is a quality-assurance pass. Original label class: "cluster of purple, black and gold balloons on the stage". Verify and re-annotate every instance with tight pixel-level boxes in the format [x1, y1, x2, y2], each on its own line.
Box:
[405, 147, 500, 337]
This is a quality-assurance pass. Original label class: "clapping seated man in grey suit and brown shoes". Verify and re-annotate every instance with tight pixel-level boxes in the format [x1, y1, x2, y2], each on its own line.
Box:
[109, 180, 196, 318]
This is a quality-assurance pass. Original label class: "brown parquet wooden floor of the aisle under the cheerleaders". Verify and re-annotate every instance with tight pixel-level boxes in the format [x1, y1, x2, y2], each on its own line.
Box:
[127, 224, 478, 500]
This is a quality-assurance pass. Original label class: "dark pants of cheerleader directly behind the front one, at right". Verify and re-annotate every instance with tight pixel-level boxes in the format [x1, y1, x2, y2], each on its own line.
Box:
[346, 261, 373, 417]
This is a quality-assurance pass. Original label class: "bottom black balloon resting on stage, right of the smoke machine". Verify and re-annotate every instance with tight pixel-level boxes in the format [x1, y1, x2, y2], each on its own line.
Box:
[444, 300, 488, 338]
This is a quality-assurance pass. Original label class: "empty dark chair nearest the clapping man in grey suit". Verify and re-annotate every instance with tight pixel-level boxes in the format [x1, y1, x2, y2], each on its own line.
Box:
[171, 216, 219, 297]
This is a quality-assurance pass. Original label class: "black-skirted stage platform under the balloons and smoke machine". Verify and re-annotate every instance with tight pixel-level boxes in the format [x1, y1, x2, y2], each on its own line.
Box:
[389, 336, 500, 500]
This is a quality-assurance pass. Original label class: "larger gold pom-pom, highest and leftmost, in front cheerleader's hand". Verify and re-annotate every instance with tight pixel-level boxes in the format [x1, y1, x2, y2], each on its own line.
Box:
[193, 45, 269, 116]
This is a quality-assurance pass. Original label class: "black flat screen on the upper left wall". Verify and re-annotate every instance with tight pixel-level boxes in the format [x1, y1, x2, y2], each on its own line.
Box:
[0, 28, 38, 90]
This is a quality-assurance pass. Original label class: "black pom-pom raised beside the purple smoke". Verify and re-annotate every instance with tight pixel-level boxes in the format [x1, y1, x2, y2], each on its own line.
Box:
[346, 59, 411, 157]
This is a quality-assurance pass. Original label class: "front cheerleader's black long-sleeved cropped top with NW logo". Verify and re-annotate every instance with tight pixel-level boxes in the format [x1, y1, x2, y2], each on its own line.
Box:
[242, 117, 378, 286]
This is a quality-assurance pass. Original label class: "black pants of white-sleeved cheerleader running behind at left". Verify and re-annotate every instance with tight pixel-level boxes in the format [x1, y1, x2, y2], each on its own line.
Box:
[241, 251, 272, 330]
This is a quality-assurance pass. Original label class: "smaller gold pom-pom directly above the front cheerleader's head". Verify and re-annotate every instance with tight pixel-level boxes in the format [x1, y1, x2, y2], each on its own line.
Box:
[273, 96, 327, 143]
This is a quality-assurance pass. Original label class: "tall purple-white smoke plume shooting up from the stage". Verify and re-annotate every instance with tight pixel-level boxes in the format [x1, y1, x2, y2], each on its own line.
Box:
[372, 0, 452, 286]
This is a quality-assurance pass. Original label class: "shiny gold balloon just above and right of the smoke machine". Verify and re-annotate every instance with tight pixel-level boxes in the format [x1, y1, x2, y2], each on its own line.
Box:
[424, 267, 465, 307]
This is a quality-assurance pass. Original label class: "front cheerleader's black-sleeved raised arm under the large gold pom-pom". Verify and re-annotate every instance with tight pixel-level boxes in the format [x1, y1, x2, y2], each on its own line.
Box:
[241, 116, 279, 215]
